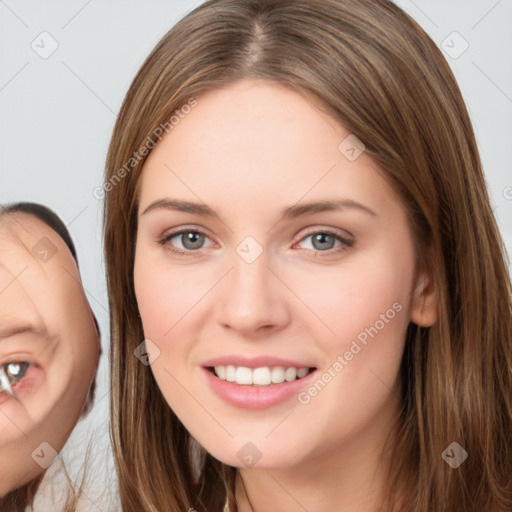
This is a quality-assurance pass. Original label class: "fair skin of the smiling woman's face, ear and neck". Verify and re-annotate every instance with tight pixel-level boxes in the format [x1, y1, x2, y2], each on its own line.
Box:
[134, 80, 436, 512]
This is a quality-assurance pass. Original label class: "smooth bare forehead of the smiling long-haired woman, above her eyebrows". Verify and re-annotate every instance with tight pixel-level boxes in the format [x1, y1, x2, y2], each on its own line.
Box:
[136, 80, 392, 229]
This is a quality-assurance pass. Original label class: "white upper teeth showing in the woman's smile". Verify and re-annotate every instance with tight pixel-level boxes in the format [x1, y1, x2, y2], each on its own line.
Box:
[214, 365, 309, 386]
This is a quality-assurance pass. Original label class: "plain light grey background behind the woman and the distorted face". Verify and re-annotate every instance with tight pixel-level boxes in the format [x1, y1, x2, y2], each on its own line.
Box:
[0, 0, 512, 512]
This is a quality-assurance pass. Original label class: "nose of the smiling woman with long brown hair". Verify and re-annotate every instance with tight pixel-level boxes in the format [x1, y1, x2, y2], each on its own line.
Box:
[217, 247, 291, 337]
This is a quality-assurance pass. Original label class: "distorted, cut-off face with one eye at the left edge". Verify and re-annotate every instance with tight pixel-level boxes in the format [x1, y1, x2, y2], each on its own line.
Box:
[0, 213, 99, 496]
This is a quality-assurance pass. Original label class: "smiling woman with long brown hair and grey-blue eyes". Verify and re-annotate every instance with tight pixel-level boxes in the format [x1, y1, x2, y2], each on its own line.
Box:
[104, 0, 512, 512]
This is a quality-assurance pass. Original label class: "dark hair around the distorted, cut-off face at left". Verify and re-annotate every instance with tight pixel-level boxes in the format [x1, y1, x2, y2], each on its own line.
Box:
[0, 201, 102, 512]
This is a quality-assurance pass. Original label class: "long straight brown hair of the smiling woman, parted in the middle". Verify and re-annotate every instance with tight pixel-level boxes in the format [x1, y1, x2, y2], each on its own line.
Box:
[102, 0, 512, 512]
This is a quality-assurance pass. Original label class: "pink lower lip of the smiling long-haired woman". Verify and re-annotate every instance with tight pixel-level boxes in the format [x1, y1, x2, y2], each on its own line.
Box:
[203, 368, 316, 410]
